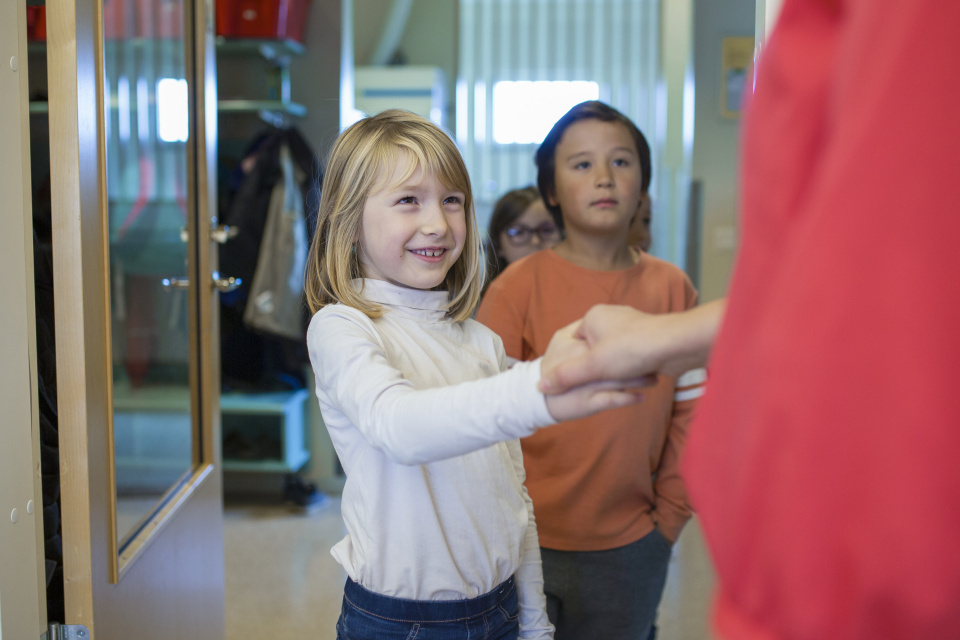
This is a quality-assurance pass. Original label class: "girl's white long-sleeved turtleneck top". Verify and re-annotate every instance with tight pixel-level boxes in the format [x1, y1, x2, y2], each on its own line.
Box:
[307, 279, 554, 638]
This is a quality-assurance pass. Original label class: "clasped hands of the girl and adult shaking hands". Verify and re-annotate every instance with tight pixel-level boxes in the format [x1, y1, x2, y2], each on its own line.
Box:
[539, 301, 726, 421]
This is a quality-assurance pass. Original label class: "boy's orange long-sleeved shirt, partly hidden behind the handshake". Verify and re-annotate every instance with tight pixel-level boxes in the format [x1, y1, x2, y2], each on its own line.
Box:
[477, 249, 699, 551]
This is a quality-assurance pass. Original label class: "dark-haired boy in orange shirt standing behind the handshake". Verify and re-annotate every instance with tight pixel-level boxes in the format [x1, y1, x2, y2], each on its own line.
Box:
[477, 102, 704, 640]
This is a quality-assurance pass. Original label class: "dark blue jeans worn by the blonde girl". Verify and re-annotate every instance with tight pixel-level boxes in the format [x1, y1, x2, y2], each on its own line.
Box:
[337, 577, 520, 640]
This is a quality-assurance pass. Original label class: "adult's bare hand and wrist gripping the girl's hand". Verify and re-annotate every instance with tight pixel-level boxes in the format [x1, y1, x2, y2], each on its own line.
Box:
[540, 300, 726, 394]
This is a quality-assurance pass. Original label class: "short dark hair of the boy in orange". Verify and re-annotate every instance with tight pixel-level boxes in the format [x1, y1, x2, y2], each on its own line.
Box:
[534, 100, 651, 225]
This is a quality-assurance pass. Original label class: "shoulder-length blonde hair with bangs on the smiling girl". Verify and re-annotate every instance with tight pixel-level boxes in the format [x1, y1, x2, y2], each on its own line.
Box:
[304, 109, 483, 321]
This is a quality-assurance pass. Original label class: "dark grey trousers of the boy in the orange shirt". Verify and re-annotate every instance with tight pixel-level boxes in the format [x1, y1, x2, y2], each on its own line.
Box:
[540, 529, 671, 640]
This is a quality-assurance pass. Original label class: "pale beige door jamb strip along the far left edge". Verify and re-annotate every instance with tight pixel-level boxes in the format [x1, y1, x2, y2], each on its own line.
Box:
[0, 2, 47, 638]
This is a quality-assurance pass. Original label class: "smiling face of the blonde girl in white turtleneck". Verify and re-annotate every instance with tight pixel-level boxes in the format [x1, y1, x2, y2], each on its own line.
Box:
[357, 154, 467, 289]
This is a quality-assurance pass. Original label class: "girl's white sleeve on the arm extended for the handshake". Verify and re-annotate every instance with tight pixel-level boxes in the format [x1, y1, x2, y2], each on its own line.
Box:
[307, 306, 555, 465]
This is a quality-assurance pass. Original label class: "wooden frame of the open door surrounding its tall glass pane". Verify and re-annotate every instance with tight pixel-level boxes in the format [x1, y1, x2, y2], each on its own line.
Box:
[46, 0, 223, 640]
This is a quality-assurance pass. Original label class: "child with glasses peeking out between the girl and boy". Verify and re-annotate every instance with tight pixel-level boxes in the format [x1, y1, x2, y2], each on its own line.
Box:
[486, 186, 561, 286]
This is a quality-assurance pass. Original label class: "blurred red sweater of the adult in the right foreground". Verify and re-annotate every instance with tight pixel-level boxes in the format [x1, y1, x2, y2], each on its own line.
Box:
[684, 0, 960, 640]
